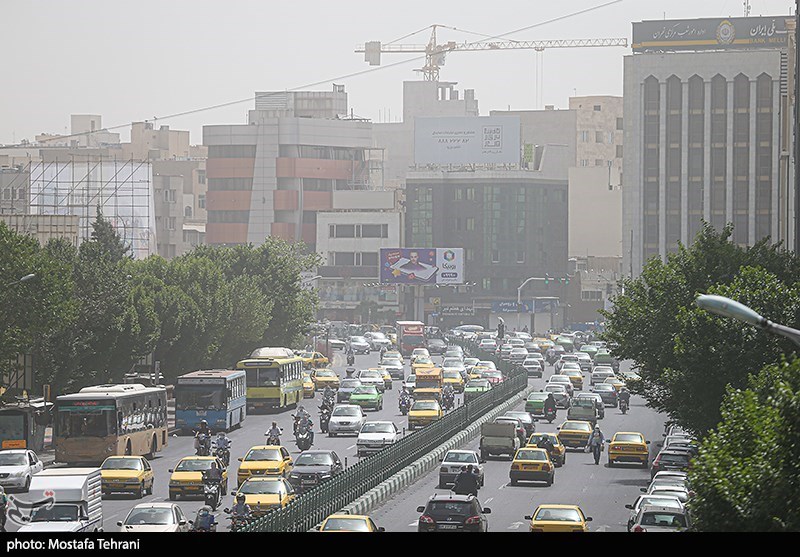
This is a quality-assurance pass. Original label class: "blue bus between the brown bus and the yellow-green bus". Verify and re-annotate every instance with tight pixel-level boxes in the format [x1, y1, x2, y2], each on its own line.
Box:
[175, 369, 247, 434]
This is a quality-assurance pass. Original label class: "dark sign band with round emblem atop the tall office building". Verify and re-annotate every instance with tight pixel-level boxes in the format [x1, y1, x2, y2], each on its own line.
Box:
[632, 16, 789, 52]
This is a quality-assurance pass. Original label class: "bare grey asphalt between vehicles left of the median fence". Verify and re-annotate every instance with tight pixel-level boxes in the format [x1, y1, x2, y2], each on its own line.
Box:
[7, 351, 444, 532]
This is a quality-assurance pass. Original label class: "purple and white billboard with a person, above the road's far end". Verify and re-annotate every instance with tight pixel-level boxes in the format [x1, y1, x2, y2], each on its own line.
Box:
[380, 248, 464, 284]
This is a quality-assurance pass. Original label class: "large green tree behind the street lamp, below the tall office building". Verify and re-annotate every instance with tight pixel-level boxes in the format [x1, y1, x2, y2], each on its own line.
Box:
[603, 224, 800, 433]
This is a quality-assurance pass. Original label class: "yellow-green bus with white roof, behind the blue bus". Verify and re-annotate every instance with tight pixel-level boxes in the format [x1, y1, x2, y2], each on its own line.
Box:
[236, 347, 303, 411]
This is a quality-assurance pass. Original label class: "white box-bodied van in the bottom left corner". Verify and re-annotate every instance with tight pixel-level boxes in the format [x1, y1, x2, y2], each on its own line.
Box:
[19, 468, 103, 532]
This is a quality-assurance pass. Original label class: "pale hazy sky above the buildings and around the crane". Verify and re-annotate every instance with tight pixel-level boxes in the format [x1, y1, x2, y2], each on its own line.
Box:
[0, 0, 794, 144]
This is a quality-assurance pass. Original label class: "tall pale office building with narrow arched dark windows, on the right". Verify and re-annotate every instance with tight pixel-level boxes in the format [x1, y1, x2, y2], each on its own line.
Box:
[622, 17, 794, 275]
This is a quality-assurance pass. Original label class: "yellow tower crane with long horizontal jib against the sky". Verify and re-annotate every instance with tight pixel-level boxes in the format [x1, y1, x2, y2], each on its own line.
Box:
[355, 25, 628, 81]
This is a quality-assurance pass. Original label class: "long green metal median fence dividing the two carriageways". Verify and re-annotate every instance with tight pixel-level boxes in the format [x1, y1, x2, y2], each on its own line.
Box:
[234, 340, 528, 532]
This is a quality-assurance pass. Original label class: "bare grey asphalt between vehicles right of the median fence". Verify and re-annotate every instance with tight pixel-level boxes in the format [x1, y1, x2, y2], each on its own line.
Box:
[370, 363, 665, 532]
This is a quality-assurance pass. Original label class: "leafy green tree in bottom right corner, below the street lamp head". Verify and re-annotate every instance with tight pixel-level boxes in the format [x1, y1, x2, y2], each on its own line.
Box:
[689, 360, 800, 532]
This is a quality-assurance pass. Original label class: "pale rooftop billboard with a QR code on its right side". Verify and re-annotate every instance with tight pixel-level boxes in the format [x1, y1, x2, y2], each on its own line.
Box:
[414, 116, 520, 164]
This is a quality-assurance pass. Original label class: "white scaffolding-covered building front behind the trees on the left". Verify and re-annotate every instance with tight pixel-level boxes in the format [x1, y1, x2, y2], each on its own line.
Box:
[30, 158, 157, 259]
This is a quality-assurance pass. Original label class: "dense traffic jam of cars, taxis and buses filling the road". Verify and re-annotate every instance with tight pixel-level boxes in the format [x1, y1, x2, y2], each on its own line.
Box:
[0, 321, 694, 532]
